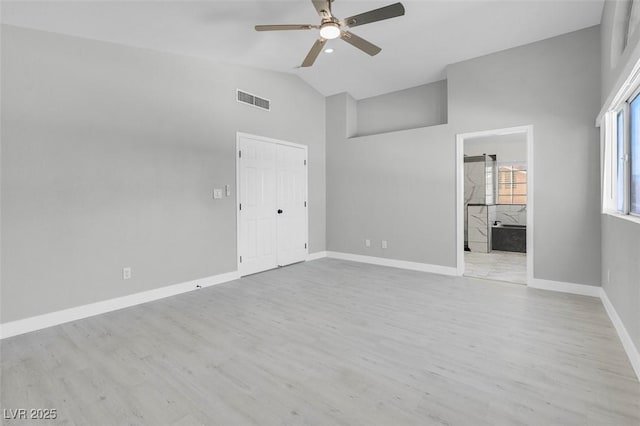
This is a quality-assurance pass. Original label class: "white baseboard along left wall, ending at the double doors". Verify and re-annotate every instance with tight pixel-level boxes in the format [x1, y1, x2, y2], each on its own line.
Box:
[0, 271, 240, 339]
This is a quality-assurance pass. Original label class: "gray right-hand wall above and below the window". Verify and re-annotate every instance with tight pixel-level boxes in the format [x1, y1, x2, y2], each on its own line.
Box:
[602, 1, 640, 348]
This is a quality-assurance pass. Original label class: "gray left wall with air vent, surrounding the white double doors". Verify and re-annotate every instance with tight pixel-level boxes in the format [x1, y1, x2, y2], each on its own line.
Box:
[0, 25, 326, 322]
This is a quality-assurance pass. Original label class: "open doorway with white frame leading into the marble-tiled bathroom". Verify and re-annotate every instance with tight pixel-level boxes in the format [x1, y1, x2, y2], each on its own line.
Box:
[456, 126, 533, 284]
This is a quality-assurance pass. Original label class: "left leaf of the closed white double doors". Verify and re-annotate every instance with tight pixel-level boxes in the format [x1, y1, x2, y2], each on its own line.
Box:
[238, 137, 278, 275]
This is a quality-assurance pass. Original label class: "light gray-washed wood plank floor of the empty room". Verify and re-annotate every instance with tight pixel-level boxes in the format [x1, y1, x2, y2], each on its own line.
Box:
[0, 259, 640, 426]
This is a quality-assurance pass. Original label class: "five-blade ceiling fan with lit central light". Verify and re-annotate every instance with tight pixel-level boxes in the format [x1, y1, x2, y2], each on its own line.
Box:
[256, 0, 404, 67]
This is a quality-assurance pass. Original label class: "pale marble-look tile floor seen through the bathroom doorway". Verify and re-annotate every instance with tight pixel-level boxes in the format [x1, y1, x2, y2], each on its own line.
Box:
[464, 250, 527, 284]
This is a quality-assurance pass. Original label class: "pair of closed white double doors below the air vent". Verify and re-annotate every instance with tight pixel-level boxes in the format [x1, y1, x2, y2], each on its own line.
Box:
[238, 135, 308, 275]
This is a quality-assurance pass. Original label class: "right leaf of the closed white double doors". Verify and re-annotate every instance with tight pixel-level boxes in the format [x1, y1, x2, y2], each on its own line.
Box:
[277, 145, 307, 266]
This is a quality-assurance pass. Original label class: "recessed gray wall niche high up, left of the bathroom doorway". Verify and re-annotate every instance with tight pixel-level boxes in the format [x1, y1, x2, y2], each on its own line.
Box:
[356, 80, 447, 136]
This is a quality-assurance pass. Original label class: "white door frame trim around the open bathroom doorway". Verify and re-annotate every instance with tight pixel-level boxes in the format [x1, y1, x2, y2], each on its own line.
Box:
[456, 125, 535, 286]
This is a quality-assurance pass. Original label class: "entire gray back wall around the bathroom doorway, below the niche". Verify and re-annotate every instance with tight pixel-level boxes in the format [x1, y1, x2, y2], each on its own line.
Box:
[327, 27, 601, 286]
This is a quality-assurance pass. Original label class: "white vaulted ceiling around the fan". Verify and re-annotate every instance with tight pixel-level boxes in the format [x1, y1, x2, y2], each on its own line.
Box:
[1, 0, 603, 99]
